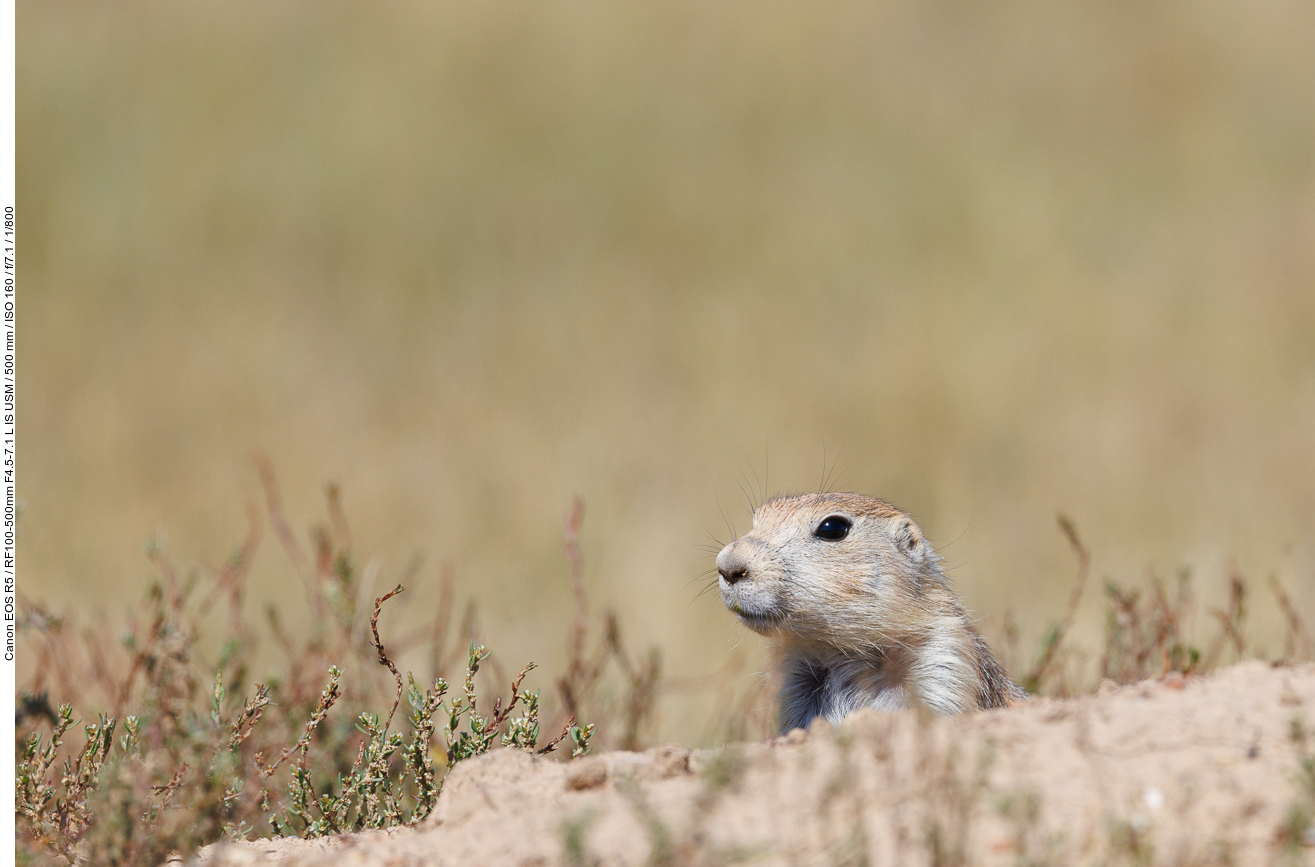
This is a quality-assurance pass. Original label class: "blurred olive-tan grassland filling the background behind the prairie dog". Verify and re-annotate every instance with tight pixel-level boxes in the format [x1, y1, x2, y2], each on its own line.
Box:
[17, 0, 1315, 739]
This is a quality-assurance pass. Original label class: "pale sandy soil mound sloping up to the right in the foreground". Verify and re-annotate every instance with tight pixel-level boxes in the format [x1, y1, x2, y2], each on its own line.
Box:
[191, 662, 1315, 867]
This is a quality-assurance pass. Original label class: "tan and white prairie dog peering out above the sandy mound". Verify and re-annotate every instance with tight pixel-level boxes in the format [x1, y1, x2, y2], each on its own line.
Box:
[717, 493, 1027, 731]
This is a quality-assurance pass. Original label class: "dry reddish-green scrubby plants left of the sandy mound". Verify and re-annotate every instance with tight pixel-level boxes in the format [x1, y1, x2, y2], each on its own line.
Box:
[17, 466, 606, 864]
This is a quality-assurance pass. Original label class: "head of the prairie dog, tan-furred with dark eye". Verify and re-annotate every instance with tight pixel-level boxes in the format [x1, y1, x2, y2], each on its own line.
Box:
[717, 493, 944, 650]
